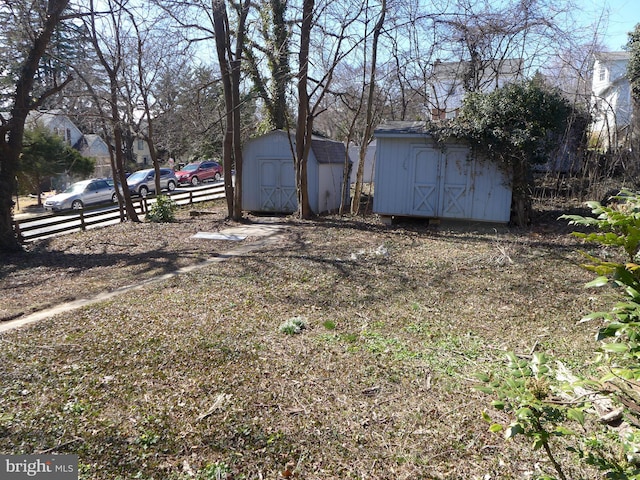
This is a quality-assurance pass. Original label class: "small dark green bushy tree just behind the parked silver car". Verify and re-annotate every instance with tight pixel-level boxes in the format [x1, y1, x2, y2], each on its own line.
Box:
[18, 127, 94, 205]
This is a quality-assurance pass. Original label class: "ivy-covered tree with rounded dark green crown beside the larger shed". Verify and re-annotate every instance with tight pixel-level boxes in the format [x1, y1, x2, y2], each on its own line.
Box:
[438, 79, 586, 226]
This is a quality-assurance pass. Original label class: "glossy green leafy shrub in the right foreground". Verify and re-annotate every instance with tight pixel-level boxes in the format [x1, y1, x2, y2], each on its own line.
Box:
[478, 190, 640, 479]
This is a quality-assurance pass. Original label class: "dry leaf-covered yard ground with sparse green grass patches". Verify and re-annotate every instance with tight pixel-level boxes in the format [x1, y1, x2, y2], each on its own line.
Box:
[0, 197, 611, 480]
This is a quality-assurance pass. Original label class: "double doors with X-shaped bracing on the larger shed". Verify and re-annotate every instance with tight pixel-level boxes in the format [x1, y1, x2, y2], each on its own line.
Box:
[411, 146, 473, 218]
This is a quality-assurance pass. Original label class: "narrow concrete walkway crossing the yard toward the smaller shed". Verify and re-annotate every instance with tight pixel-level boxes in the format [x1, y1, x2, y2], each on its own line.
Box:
[0, 223, 285, 333]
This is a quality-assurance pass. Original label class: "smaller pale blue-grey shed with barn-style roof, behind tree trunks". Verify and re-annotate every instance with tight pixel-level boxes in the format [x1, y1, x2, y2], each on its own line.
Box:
[242, 130, 348, 214]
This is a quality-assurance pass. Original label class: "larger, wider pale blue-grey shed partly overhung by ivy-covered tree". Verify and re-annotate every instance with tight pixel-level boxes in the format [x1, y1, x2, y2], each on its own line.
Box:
[373, 122, 511, 223]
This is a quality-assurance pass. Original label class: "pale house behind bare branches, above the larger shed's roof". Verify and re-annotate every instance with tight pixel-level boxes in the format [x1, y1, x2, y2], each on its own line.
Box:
[427, 59, 523, 121]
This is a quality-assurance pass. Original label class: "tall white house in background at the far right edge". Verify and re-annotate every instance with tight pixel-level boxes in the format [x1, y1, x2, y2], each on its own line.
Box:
[591, 52, 632, 150]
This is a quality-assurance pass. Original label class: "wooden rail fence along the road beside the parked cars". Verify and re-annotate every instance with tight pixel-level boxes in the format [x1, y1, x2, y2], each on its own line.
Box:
[13, 185, 224, 243]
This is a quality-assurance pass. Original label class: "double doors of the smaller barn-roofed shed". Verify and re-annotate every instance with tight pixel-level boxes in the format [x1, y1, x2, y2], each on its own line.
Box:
[260, 158, 298, 212]
